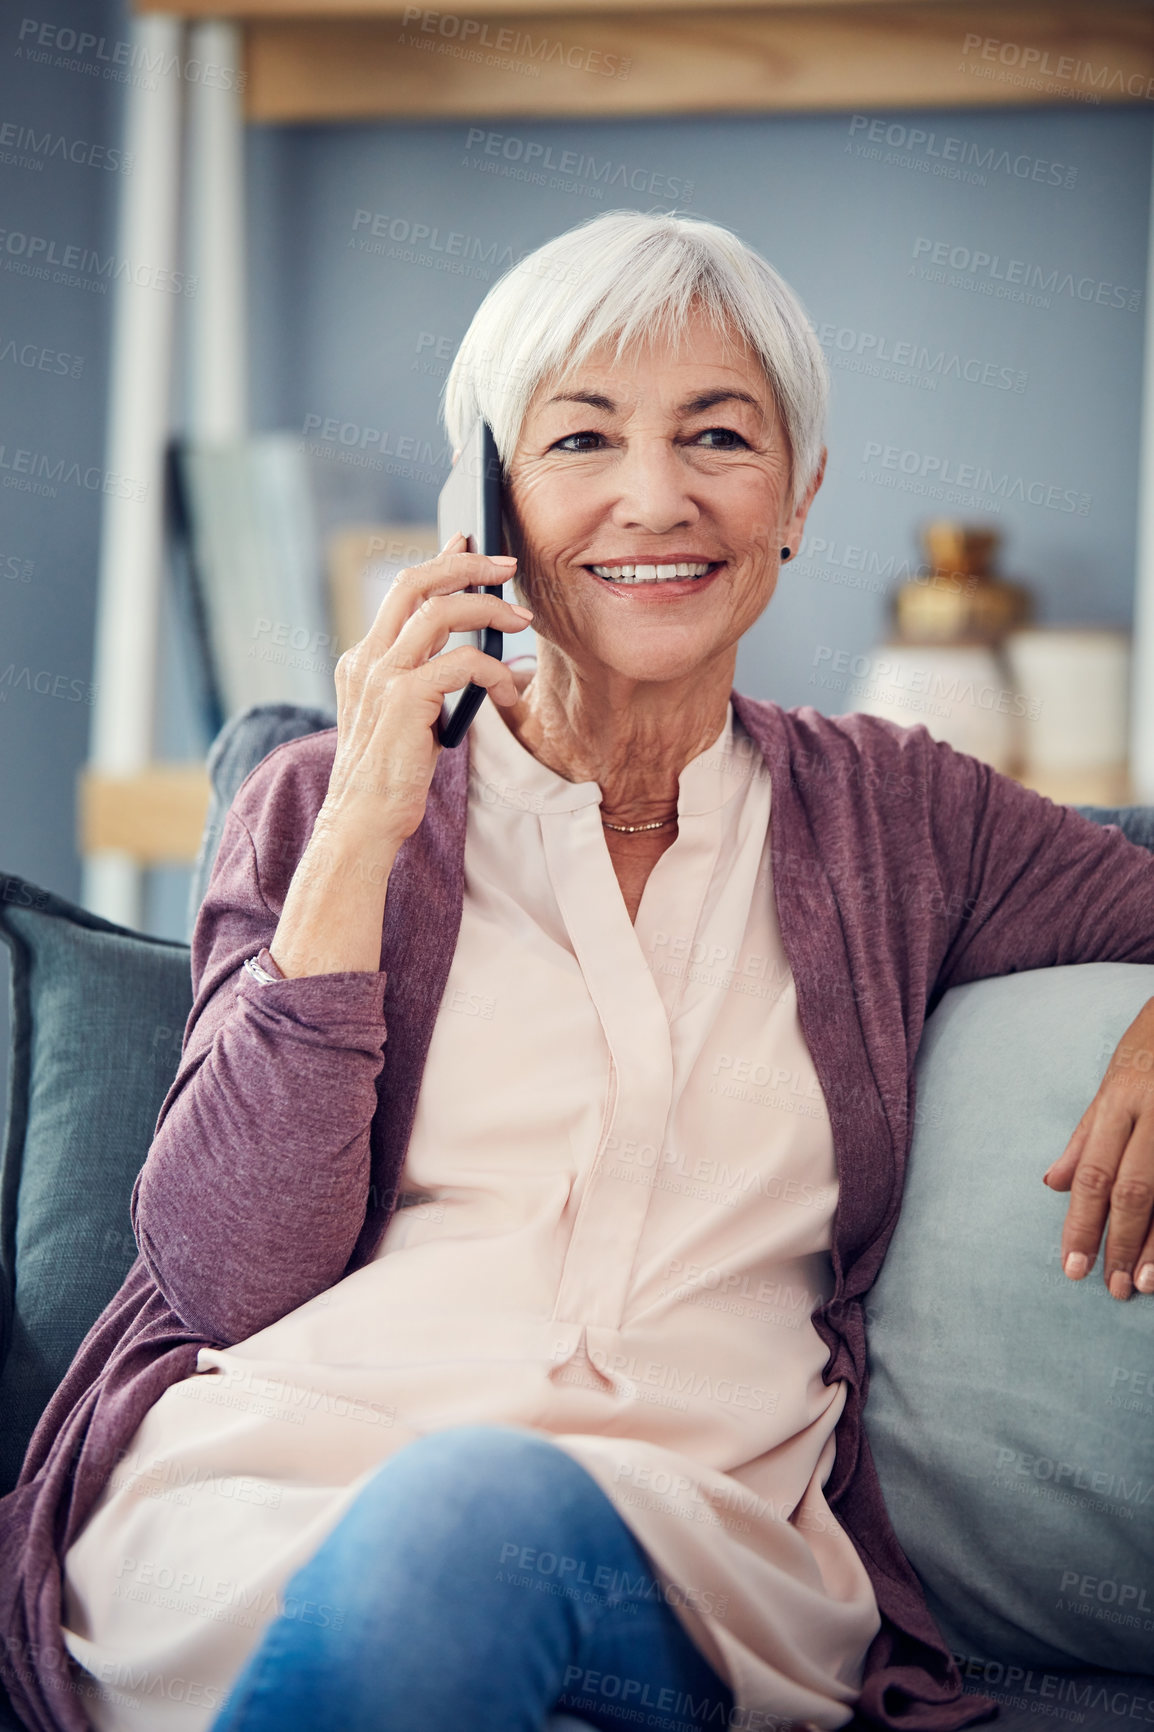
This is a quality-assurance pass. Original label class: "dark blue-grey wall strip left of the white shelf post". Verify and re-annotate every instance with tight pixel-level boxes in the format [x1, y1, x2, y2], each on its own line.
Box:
[0, 0, 125, 1136]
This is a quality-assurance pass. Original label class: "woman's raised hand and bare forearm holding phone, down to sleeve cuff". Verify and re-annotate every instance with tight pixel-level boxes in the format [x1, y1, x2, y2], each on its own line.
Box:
[269, 535, 532, 979]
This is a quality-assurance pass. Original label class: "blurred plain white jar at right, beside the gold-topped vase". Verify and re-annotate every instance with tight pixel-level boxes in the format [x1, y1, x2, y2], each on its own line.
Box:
[1005, 625, 1130, 798]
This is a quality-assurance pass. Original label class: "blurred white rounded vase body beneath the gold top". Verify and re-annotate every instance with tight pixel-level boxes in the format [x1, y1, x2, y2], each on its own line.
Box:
[846, 643, 1021, 774]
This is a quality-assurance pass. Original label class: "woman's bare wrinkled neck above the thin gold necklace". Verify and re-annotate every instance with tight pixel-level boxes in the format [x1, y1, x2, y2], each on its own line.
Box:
[501, 643, 736, 824]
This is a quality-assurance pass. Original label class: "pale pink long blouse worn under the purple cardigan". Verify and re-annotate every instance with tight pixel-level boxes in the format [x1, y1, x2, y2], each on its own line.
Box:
[64, 703, 880, 1732]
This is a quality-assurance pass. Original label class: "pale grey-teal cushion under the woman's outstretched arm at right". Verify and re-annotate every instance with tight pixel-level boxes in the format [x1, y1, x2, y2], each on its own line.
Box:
[865, 963, 1154, 1676]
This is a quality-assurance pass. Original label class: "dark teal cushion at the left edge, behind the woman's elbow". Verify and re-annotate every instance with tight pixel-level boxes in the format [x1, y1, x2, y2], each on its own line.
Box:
[0, 875, 192, 1493]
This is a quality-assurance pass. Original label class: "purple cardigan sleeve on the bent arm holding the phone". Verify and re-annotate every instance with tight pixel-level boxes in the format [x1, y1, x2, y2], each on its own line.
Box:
[132, 741, 385, 1346]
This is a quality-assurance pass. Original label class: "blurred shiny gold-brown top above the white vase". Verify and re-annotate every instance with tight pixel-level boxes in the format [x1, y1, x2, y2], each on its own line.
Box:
[894, 518, 1033, 644]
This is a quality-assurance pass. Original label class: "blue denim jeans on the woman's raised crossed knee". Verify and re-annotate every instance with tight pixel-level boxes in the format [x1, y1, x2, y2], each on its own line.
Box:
[213, 1425, 733, 1732]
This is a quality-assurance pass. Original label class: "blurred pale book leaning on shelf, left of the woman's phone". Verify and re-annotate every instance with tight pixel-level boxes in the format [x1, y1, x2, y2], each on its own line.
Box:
[175, 433, 336, 717]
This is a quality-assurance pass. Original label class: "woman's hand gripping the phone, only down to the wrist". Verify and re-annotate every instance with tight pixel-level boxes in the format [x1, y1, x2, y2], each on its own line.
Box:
[317, 535, 532, 854]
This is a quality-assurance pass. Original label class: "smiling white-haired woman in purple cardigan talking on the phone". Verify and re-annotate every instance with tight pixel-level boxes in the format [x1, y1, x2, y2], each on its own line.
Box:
[0, 211, 1154, 1732]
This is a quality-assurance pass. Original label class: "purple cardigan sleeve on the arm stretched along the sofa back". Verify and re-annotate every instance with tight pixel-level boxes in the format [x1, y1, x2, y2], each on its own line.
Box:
[917, 729, 1154, 999]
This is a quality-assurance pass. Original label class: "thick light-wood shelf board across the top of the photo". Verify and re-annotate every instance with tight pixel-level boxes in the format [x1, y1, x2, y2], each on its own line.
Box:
[220, 0, 1154, 123]
